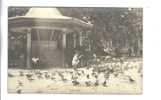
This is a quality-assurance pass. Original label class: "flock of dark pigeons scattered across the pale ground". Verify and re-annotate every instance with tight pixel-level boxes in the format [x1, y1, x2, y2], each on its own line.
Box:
[8, 57, 142, 93]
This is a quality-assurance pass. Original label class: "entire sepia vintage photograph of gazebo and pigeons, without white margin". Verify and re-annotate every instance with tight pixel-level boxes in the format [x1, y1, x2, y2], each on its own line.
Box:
[7, 6, 143, 94]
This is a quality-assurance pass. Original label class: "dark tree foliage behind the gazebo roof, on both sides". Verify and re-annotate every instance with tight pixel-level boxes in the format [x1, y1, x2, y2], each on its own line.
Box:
[8, 7, 143, 55]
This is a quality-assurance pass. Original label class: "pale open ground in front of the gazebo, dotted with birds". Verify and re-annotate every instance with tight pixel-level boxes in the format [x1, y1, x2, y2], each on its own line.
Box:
[8, 58, 142, 94]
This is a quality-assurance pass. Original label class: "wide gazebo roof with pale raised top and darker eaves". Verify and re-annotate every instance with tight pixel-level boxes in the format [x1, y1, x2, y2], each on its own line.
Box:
[8, 8, 93, 30]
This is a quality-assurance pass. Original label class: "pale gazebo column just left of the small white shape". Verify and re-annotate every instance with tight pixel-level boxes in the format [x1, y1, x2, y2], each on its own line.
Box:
[26, 29, 31, 68]
